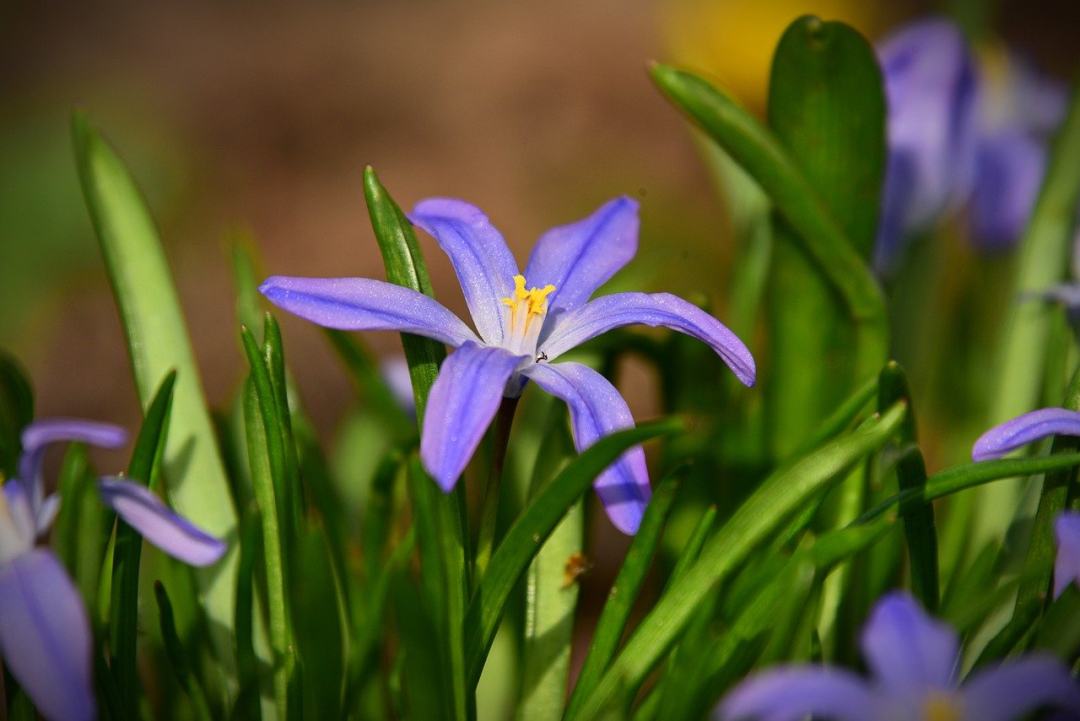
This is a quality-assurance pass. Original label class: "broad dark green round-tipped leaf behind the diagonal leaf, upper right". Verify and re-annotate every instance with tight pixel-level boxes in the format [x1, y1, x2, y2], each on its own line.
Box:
[766, 16, 886, 458]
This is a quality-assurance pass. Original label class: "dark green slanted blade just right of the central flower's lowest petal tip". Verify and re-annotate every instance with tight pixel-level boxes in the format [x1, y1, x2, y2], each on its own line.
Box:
[567, 474, 681, 715]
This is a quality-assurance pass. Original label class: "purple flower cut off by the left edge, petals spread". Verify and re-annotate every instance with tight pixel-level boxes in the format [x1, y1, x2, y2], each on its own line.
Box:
[0, 420, 225, 721]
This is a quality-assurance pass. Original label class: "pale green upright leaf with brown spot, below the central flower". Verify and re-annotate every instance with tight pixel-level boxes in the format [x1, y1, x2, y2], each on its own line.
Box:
[517, 422, 585, 721]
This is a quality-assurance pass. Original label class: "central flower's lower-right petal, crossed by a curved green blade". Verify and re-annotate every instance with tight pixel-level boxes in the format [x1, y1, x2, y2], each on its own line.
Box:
[523, 363, 651, 534]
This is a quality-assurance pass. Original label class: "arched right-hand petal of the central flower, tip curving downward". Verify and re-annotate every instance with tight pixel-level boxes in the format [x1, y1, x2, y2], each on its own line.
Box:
[540, 293, 756, 385]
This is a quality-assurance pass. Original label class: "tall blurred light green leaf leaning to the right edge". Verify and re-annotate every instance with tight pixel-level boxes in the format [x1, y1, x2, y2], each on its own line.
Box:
[969, 84, 1080, 544]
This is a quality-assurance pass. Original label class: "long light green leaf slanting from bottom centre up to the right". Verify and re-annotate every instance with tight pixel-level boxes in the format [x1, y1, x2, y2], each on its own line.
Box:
[570, 404, 906, 720]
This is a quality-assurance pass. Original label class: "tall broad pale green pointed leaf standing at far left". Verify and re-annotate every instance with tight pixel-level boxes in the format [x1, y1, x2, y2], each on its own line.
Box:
[72, 113, 238, 660]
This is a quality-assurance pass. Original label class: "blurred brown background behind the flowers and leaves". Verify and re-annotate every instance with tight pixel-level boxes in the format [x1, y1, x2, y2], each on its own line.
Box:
[0, 0, 1080, 428]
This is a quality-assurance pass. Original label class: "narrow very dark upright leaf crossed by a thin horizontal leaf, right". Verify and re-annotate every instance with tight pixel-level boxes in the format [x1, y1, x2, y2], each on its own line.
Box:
[878, 361, 941, 613]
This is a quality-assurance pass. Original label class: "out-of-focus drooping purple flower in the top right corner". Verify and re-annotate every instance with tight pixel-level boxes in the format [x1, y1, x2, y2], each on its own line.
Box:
[876, 18, 1066, 270]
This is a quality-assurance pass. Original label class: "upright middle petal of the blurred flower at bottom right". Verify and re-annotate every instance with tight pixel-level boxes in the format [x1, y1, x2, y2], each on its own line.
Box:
[862, 591, 958, 698]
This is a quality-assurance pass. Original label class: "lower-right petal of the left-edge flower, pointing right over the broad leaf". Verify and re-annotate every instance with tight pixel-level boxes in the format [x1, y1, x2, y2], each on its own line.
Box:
[97, 478, 226, 566]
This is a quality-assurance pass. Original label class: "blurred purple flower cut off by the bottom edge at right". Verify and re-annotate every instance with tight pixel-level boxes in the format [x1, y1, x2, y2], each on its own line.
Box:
[718, 593, 1080, 721]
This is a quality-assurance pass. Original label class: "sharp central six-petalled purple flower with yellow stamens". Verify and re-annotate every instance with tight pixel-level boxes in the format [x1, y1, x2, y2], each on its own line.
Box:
[260, 198, 755, 533]
